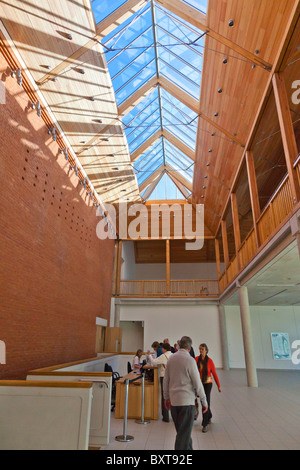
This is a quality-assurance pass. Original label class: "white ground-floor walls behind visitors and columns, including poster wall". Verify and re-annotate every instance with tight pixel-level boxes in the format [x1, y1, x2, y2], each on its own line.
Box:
[116, 299, 300, 370]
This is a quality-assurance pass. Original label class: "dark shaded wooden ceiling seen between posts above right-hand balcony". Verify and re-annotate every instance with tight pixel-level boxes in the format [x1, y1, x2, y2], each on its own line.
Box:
[218, 13, 300, 258]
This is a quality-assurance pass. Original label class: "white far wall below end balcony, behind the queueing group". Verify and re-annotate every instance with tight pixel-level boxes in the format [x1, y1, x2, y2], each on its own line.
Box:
[120, 299, 223, 367]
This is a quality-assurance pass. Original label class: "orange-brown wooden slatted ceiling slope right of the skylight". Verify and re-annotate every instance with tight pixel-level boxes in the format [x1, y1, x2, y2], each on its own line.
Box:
[193, 0, 293, 233]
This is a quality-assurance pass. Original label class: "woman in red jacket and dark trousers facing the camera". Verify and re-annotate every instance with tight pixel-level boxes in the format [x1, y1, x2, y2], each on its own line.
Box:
[195, 343, 221, 432]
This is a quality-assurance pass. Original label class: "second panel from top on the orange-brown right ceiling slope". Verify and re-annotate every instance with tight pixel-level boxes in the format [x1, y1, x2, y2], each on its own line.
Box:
[200, 37, 269, 145]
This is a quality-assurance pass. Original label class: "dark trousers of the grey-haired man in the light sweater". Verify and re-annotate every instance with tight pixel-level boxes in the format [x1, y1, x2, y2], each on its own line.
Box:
[171, 405, 195, 450]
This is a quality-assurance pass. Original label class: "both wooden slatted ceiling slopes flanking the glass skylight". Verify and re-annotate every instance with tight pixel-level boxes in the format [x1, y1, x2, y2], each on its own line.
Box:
[0, 0, 298, 250]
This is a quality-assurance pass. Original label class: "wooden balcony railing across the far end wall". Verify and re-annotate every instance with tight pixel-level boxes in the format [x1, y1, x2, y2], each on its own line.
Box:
[120, 279, 219, 298]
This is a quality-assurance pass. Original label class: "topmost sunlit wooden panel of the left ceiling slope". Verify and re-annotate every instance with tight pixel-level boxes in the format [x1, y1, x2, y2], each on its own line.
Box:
[0, 0, 95, 81]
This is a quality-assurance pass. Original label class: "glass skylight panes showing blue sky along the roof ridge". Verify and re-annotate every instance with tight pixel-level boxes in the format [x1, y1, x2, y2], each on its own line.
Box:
[93, 0, 203, 199]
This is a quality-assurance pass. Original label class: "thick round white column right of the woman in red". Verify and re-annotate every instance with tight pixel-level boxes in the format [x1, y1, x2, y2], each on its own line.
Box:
[238, 286, 257, 387]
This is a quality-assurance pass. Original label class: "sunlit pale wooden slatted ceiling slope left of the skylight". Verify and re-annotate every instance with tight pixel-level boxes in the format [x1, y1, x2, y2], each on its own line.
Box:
[0, 0, 140, 206]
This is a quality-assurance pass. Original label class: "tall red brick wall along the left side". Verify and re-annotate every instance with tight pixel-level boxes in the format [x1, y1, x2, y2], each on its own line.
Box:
[0, 54, 114, 379]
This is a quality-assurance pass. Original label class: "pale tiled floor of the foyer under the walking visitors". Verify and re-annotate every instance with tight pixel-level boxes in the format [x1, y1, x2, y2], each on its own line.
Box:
[102, 369, 300, 451]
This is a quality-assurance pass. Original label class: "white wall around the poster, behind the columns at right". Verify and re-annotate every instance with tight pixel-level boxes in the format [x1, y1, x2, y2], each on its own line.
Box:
[225, 306, 300, 370]
